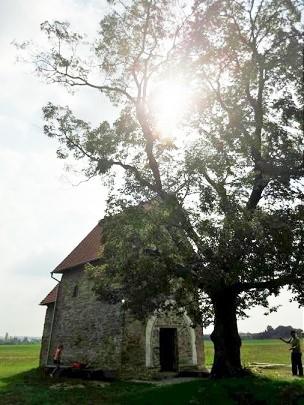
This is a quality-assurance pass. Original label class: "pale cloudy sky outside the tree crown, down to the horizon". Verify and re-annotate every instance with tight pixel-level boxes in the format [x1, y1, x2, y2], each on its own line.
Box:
[0, 0, 304, 336]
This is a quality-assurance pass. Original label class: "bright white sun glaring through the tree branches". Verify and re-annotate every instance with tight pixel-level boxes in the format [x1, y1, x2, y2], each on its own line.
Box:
[149, 81, 190, 139]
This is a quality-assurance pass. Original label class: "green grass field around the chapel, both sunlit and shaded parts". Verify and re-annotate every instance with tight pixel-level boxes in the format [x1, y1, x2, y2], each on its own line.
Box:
[0, 340, 304, 405]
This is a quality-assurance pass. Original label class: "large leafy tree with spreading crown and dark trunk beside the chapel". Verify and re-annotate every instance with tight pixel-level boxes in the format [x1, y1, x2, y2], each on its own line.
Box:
[27, 0, 304, 377]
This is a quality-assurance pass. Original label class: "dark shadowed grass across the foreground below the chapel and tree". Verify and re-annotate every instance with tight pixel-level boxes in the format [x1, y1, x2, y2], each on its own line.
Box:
[0, 369, 304, 405]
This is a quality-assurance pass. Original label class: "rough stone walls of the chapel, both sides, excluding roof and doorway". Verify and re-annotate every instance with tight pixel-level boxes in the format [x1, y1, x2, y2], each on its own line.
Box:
[40, 267, 204, 378]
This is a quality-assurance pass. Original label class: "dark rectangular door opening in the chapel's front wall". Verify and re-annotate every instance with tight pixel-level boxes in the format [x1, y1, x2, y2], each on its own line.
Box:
[159, 328, 178, 371]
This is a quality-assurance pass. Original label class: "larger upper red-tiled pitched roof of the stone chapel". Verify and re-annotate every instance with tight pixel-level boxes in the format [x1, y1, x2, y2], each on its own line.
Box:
[52, 224, 102, 273]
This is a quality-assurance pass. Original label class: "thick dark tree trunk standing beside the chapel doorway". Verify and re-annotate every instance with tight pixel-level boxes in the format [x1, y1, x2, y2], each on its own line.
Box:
[211, 289, 243, 378]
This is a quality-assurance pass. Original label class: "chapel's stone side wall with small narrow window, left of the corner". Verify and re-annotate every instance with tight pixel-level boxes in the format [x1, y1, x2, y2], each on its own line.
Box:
[42, 267, 122, 370]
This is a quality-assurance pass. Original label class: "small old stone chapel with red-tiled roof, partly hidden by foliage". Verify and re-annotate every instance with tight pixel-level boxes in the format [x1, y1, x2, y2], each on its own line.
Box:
[40, 219, 205, 378]
